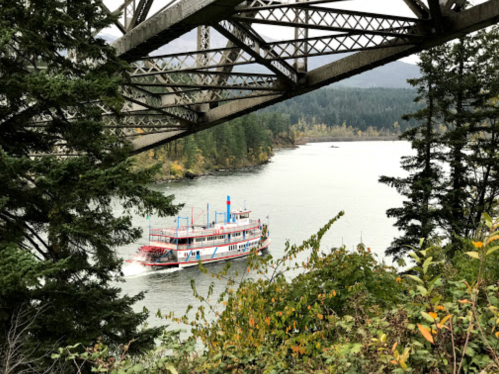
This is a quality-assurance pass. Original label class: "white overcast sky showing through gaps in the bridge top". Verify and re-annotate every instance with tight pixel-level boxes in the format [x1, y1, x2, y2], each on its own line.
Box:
[100, 0, 486, 63]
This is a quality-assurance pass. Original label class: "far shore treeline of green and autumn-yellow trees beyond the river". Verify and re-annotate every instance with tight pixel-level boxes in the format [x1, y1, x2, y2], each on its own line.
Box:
[136, 88, 420, 181]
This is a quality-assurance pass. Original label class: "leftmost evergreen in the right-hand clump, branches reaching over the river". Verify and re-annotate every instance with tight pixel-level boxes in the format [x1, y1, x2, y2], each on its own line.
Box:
[380, 46, 447, 258]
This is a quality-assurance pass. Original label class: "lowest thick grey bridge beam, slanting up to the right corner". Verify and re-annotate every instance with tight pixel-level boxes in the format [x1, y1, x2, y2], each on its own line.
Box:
[132, 0, 499, 153]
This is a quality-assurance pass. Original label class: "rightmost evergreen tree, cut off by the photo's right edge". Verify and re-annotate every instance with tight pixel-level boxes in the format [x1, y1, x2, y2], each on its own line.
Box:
[458, 27, 499, 236]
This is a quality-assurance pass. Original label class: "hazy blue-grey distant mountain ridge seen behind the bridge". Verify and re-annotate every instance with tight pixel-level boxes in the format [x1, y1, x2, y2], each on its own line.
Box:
[100, 30, 421, 88]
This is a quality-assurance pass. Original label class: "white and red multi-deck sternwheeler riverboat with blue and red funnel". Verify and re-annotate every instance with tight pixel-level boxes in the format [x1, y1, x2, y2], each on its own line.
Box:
[126, 196, 271, 268]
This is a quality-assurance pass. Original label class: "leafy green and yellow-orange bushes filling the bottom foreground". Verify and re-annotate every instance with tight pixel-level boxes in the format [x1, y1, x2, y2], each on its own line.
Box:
[56, 213, 499, 374]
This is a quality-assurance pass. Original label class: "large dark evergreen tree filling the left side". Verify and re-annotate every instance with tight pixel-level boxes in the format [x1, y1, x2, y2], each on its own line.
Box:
[0, 0, 178, 371]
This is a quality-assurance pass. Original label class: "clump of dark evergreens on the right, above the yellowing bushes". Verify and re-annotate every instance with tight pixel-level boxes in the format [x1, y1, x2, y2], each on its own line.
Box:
[381, 28, 499, 256]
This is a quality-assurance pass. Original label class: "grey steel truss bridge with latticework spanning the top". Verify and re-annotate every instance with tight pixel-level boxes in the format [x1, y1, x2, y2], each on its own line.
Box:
[64, 0, 499, 153]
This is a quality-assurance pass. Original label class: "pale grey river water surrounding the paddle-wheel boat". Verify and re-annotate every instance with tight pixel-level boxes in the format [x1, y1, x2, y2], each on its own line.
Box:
[118, 142, 411, 326]
